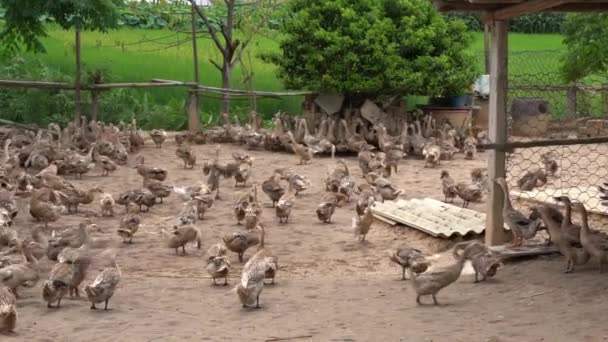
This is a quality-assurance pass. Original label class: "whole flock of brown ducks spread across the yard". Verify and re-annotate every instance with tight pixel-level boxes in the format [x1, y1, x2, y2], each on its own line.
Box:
[0, 112, 608, 332]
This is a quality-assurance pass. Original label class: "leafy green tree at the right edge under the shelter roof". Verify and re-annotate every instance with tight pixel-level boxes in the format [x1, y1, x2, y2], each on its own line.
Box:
[562, 13, 608, 82]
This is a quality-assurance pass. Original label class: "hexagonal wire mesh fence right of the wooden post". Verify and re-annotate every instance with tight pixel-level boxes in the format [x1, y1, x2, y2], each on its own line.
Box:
[498, 51, 608, 220]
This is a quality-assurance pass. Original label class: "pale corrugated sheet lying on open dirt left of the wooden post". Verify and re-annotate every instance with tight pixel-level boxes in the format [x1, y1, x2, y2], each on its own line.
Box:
[372, 198, 508, 238]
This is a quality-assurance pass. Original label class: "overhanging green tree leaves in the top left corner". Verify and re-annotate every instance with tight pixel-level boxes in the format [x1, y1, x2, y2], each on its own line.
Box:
[0, 0, 122, 54]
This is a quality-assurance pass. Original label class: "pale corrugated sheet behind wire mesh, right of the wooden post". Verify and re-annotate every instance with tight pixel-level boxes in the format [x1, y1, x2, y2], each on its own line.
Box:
[510, 186, 608, 215]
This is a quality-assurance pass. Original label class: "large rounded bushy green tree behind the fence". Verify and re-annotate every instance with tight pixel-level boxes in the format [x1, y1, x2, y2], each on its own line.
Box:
[263, 0, 476, 95]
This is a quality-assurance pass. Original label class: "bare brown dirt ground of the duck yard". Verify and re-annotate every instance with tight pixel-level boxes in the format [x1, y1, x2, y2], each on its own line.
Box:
[7, 141, 608, 341]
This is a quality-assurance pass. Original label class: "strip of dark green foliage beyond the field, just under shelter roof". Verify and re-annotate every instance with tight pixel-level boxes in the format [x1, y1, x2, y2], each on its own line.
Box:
[446, 12, 566, 33]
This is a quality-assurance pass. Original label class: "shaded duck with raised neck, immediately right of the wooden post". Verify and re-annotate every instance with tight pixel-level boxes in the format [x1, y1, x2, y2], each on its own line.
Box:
[494, 178, 540, 247]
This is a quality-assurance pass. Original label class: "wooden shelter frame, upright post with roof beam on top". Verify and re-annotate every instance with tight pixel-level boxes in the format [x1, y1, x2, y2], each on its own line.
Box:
[432, 0, 608, 245]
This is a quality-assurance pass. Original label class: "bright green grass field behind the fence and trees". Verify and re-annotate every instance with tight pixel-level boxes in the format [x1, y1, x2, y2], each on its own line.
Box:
[10, 28, 588, 125]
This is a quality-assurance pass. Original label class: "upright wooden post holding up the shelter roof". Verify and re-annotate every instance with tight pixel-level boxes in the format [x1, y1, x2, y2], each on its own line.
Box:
[485, 21, 509, 246]
